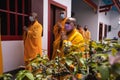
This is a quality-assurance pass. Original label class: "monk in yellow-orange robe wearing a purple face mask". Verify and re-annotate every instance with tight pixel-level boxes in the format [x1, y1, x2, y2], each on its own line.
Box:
[61, 17, 84, 56]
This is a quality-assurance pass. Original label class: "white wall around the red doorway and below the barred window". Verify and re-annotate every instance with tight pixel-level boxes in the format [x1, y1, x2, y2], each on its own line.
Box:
[2, 0, 71, 72]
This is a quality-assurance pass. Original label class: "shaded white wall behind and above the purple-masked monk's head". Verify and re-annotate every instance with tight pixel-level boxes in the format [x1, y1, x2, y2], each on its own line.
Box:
[72, 0, 98, 40]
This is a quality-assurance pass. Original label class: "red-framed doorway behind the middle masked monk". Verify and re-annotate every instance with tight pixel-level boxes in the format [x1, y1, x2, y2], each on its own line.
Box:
[48, 0, 67, 59]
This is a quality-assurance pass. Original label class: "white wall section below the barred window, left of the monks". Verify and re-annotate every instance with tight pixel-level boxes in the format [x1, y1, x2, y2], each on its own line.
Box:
[2, 41, 24, 72]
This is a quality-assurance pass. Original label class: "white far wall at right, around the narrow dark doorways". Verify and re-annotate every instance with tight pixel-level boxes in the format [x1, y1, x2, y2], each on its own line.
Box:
[98, 1, 120, 39]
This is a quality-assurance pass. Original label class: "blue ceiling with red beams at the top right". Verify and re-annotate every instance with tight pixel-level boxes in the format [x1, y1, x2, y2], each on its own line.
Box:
[83, 0, 120, 13]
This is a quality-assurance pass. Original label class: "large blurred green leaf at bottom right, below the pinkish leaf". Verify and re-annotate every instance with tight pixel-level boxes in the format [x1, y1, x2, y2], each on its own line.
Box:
[98, 66, 109, 80]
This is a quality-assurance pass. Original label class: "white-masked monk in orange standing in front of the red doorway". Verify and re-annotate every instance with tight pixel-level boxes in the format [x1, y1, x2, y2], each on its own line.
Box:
[51, 10, 67, 59]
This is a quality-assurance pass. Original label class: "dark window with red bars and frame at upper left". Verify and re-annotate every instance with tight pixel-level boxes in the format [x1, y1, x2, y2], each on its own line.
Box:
[0, 0, 31, 40]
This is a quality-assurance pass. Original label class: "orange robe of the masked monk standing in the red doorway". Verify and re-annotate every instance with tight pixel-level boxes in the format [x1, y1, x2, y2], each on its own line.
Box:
[52, 18, 67, 59]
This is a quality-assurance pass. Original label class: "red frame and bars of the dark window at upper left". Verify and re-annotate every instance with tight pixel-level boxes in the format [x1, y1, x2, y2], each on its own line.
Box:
[0, 0, 31, 40]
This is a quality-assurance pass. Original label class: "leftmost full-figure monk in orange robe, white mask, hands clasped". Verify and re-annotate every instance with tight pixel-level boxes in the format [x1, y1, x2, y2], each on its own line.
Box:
[23, 12, 42, 69]
